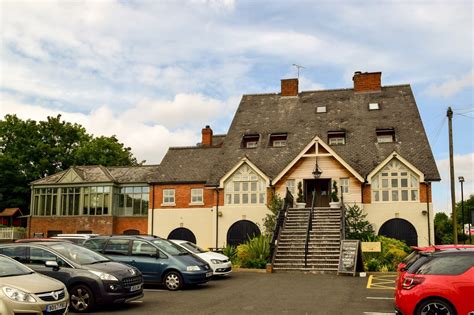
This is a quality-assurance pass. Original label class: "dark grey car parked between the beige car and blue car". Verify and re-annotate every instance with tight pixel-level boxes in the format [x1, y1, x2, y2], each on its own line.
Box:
[0, 241, 143, 312]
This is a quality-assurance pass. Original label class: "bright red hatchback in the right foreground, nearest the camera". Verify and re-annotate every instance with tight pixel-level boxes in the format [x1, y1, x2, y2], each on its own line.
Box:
[395, 248, 474, 315]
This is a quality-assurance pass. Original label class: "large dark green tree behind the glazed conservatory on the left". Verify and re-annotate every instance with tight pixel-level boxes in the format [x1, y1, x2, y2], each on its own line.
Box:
[0, 115, 137, 214]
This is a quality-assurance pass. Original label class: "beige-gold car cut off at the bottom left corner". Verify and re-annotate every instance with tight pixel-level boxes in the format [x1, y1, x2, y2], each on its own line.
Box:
[0, 255, 69, 315]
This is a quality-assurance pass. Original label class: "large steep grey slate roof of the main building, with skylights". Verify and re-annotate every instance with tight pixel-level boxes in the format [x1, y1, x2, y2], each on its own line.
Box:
[208, 85, 440, 183]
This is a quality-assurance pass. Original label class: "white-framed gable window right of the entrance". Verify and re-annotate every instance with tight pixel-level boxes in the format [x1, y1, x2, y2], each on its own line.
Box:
[371, 159, 420, 203]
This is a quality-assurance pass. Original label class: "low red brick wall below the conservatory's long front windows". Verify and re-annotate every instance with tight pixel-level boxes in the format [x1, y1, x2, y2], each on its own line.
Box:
[29, 216, 113, 237]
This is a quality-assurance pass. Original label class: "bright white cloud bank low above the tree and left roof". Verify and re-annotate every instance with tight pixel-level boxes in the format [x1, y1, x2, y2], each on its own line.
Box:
[0, 93, 237, 164]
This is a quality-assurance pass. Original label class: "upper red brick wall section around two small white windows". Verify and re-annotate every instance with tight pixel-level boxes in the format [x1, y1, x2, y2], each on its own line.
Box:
[150, 184, 218, 209]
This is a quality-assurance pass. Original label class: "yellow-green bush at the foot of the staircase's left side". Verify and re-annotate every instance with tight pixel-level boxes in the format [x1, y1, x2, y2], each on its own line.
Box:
[237, 235, 270, 269]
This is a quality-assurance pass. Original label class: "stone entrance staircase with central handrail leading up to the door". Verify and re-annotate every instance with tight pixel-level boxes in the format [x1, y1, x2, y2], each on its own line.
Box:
[273, 208, 341, 272]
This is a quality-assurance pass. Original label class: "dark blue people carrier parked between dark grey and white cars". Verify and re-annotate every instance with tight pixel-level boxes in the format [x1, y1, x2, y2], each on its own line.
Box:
[84, 235, 212, 291]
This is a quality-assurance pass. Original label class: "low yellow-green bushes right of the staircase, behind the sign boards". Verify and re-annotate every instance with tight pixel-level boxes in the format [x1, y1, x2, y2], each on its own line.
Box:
[362, 235, 411, 271]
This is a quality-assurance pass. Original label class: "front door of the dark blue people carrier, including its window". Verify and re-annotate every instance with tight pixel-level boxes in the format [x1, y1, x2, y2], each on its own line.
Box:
[131, 240, 168, 283]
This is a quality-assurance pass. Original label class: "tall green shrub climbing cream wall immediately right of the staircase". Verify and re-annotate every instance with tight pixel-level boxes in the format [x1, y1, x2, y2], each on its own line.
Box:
[346, 204, 375, 241]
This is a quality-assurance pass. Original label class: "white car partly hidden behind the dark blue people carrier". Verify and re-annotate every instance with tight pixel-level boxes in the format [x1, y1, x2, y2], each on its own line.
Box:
[170, 240, 232, 276]
